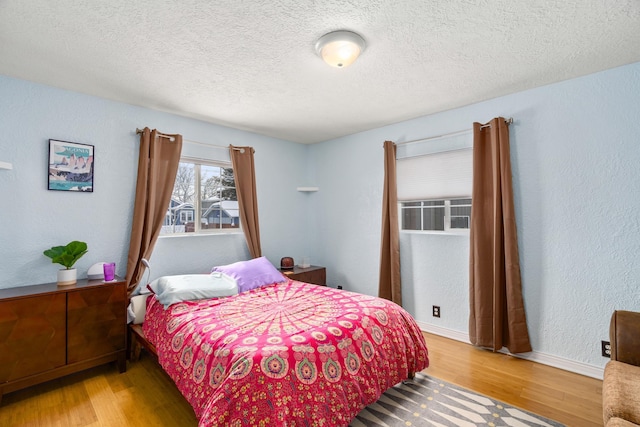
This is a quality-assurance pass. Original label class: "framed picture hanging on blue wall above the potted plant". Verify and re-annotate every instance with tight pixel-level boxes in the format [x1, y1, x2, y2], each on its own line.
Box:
[49, 139, 94, 193]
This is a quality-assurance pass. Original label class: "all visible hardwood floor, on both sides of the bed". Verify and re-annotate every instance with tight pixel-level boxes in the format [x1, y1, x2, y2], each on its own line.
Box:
[0, 333, 602, 427]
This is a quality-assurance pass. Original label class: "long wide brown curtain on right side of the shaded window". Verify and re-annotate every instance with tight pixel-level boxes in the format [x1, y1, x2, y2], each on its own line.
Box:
[469, 117, 531, 353]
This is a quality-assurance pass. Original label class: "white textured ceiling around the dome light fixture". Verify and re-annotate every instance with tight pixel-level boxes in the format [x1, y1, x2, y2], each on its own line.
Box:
[0, 0, 640, 143]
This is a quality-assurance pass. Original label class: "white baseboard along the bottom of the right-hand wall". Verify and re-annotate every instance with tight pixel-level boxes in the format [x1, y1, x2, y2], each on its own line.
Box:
[417, 321, 604, 380]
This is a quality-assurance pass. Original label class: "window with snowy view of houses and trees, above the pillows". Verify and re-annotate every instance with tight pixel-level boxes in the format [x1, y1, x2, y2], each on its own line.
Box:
[161, 159, 240, 235]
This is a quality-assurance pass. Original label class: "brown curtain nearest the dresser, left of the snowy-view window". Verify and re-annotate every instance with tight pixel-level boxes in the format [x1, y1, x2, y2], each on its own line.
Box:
[126, 128, 182, 293]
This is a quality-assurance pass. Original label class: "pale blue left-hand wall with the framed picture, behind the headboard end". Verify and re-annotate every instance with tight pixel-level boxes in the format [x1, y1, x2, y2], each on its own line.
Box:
[0, 76, 308, 288]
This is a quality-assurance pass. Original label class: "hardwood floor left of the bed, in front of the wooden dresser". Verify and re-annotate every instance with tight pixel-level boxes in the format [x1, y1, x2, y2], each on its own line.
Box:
[0, 352, 198, 427]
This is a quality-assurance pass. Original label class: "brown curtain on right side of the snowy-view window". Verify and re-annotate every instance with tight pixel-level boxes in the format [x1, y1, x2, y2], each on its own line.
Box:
[229, 145, 262, 258]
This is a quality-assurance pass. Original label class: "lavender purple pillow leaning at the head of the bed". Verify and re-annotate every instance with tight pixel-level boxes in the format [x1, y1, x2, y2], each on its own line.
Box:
[211, 257, 286, 292]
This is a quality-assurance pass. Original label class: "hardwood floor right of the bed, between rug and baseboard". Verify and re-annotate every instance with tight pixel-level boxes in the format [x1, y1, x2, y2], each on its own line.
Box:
[424, 333, 602, 427]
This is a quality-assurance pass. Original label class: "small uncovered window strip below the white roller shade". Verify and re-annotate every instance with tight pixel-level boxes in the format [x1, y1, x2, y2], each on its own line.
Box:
[400, 199, 471, 231]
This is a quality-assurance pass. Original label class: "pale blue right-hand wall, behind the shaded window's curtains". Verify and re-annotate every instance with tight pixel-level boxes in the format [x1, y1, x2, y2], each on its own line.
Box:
[310, 63, 640, 374]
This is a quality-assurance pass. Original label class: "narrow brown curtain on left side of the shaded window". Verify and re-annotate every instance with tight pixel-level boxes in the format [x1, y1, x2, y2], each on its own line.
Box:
[378, 141, 402, 305]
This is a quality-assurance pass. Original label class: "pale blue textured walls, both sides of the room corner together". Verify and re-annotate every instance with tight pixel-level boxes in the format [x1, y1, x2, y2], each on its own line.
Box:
[0, 63, 640, 374]
